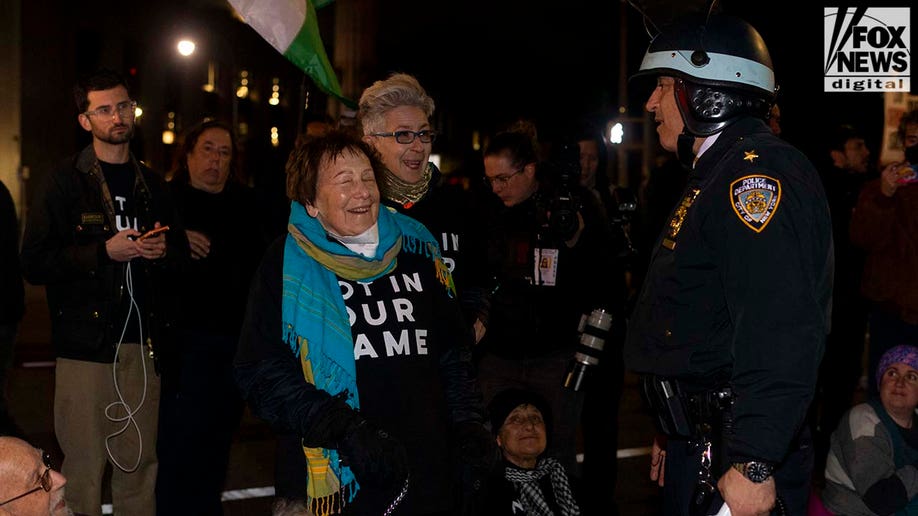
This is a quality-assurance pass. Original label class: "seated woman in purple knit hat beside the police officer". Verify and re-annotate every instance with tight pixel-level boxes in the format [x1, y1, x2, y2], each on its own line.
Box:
[822, 346, 918, 516]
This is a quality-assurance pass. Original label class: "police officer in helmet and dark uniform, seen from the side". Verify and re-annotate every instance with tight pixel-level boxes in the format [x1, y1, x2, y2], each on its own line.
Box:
[625, 15, 834, 516]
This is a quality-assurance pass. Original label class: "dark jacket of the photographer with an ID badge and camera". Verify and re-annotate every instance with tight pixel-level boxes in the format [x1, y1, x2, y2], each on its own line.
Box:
[478, 183, 624, 359]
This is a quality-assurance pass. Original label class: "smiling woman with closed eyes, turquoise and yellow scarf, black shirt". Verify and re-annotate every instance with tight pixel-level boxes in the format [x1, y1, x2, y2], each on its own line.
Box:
[236, 132, 482, 515]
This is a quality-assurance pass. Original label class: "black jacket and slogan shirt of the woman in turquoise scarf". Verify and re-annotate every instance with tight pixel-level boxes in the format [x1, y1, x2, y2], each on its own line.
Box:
[235, 237, 484, 514]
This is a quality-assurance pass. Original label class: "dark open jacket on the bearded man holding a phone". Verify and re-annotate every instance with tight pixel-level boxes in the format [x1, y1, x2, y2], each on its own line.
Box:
[20, 145, 188, 362]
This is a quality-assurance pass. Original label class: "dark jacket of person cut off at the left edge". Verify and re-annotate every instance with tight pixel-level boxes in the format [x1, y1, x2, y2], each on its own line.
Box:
[0, 183, 25, 324]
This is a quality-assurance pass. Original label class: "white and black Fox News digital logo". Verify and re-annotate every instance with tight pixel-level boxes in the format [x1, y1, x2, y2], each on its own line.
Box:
[824, 7, 911, 91]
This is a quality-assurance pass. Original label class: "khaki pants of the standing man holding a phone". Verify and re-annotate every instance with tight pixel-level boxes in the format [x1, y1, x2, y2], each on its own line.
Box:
[54, 344, 159, 516]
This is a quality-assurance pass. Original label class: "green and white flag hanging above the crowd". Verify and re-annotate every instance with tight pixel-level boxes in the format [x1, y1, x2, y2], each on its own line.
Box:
[228, 0, 356, 107]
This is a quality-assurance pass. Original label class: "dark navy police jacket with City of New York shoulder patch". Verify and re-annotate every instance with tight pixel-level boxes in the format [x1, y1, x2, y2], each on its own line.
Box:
[625, 118, 834, 463]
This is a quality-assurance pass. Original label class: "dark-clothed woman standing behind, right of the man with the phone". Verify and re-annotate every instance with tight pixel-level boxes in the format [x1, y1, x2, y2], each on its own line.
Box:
[156, 120, 267, 514]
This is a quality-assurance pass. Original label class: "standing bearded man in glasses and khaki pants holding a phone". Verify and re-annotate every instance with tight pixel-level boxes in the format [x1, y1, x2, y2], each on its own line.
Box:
[20, 70, 188, 516]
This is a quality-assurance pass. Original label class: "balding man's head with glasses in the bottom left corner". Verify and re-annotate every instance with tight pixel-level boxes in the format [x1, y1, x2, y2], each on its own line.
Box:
[0, 436, 73, 516]
